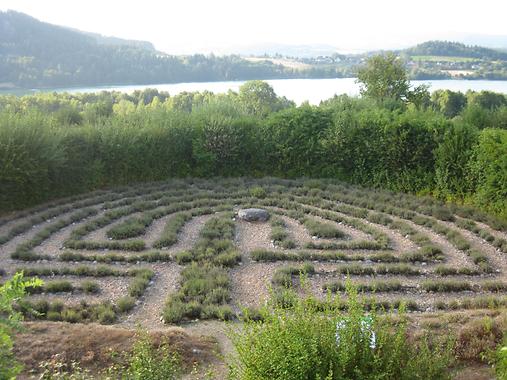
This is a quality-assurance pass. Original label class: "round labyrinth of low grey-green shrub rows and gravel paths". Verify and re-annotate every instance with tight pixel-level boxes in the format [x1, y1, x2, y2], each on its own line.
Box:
[0, 178, 507, 327]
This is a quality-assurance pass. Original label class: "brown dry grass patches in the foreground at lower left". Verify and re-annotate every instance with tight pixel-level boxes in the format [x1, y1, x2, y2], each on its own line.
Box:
[14, 322, 216, 376]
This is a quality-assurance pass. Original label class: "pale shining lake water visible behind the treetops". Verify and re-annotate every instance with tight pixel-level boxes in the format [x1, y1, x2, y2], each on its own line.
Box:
[7, 78, 507, 104]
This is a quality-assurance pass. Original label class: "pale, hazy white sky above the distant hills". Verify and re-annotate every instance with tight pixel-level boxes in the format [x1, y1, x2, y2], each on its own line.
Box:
[0, 0, 507, 53]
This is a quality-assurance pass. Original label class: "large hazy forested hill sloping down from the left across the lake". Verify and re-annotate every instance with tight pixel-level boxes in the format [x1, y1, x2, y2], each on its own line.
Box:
[0, 11, 324, 88]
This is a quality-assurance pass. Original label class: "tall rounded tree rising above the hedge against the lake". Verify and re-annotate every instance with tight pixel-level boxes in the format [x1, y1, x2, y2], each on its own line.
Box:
[357, 53, 410, 102]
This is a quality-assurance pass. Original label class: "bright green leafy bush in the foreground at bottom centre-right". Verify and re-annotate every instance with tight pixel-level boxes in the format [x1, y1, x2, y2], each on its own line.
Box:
[229, 288, 452, 380]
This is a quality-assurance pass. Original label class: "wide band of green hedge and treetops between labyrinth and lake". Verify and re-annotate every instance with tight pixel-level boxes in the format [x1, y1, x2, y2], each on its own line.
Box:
[0, 76, 507, 219]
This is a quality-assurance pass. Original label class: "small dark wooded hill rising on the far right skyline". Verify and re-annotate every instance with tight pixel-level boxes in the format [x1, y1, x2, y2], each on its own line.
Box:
[403, 41, 507, 61]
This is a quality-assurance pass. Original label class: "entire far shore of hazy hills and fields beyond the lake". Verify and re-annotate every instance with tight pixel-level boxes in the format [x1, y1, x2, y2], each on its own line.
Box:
[0, 11, 507, 89]
